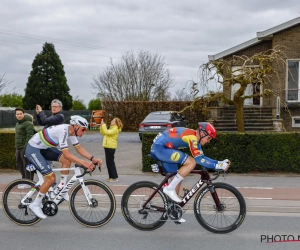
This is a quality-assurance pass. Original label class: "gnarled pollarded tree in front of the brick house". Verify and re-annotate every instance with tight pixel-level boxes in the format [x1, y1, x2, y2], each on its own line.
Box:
[191, 49, 285, 132]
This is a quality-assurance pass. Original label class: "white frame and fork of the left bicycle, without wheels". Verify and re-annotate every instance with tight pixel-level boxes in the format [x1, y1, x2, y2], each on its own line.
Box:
[21, 167, 92, 205]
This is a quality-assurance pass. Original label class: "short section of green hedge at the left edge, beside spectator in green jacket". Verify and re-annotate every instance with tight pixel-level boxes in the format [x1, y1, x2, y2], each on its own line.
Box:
[0, 130, 16, 169]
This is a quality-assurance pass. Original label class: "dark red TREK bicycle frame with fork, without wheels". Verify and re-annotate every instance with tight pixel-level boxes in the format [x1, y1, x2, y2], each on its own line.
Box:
[142, 165, 222, 212]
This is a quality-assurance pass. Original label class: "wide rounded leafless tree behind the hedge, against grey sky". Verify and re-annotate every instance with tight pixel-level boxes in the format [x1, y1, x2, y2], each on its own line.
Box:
[91, 51, 173, 101]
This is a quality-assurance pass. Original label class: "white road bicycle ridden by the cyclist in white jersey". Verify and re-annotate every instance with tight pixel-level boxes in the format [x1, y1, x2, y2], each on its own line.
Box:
[2, 164, 116, 227]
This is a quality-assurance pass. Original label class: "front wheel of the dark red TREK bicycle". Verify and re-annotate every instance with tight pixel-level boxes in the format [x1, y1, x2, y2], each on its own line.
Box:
[194, 182, 246, 234]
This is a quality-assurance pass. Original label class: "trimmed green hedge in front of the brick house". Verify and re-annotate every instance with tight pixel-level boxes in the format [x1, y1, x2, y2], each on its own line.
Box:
[142, 132, 300, 173]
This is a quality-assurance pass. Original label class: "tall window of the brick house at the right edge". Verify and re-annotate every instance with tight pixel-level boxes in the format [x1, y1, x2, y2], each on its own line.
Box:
[287, 61, 300, 102]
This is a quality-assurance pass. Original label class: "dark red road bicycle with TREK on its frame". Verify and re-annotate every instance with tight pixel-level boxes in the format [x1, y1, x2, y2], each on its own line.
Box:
[121, 161, 246, 234]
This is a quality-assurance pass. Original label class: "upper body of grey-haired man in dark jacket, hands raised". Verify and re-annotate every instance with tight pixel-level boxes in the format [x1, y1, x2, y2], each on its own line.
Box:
[36, 99, 65, 127]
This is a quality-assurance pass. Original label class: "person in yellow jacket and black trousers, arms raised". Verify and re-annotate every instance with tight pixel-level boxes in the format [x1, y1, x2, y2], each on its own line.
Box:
[100, 118, 123, 182]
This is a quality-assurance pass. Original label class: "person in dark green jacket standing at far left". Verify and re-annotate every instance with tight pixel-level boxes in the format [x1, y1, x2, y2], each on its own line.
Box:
[15, 108, 36, 189]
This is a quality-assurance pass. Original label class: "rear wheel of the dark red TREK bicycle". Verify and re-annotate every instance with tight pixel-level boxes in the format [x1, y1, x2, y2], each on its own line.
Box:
[121, 181, 168, 231]
